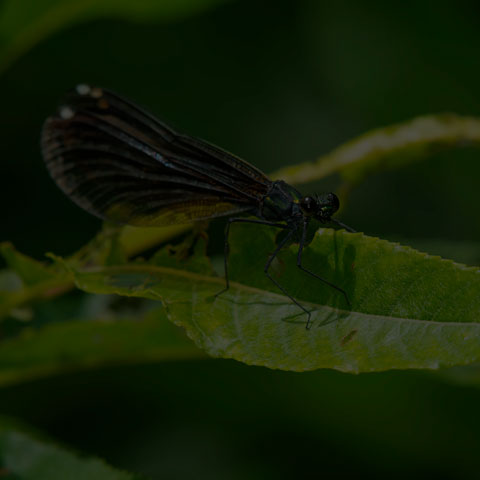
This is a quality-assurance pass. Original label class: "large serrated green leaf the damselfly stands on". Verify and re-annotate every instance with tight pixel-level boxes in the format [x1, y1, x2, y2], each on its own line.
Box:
[68, 225, 480, 372]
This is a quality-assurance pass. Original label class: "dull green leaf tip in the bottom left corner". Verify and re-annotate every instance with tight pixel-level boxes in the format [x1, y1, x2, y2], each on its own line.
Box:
[0, 418, 141, 480]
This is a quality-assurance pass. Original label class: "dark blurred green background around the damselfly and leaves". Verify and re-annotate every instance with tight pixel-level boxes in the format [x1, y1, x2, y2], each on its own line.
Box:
[0, 0, 480, 479]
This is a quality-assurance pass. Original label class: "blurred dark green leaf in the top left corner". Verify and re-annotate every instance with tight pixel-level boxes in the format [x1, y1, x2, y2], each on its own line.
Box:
[0, 0, 230, 71]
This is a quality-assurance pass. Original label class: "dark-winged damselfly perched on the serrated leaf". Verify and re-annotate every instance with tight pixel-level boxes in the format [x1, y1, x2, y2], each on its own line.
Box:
[41, 84, 353, 328]
